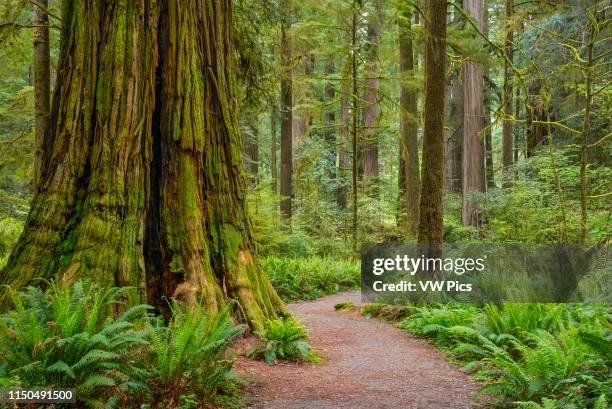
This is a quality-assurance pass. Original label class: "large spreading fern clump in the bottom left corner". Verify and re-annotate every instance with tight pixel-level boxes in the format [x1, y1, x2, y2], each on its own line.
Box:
[0, 283, 150, 407]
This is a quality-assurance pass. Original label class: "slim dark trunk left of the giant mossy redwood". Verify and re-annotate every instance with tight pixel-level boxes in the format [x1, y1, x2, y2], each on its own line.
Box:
[32, 0, 51, 186]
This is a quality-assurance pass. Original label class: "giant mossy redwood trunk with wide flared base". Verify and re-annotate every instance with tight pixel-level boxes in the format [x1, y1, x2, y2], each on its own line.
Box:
[0, 0, 286, 330]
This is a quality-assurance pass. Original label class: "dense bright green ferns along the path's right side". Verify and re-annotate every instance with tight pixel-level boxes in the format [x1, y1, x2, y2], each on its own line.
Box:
[398, 304, 612, 408]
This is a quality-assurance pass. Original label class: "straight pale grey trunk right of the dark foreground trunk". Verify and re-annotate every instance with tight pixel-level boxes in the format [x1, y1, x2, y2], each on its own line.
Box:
[461, 0, 485, 227]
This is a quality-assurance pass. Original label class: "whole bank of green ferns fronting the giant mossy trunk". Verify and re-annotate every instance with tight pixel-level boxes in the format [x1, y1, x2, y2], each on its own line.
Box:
[0, 282, 249, 408]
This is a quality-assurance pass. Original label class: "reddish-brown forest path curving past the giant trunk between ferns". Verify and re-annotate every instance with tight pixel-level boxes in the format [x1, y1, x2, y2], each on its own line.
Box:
[234, 292, 477, 409]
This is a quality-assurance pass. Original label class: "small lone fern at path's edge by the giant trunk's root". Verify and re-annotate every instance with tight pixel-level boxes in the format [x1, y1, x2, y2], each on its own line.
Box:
[248, 317, 318, 364]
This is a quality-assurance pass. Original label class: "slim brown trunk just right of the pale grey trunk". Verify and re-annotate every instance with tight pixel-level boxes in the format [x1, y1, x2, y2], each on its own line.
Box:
[502, 0, 514, 187]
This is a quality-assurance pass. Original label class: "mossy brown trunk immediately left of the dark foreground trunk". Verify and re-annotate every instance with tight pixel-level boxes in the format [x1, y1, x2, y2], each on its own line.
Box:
[398, 4, 421, 236]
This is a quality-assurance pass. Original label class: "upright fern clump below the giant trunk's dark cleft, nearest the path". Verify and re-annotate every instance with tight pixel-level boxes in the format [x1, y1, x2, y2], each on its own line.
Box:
[150, 302, 245, 402]
